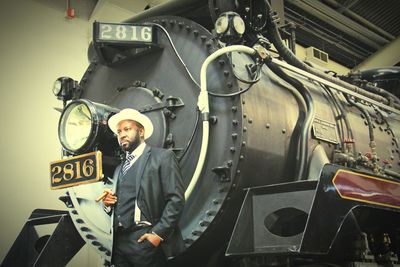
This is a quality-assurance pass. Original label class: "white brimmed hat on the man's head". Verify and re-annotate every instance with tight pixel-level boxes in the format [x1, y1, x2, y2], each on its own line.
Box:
[108, 108, 154, 139]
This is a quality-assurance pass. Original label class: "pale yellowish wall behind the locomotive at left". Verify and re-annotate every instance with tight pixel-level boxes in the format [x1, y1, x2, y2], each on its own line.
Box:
[0, 0, 140, 266]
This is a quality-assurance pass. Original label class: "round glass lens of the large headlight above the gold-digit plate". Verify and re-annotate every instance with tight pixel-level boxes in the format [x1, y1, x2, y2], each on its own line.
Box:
[59, 102, 93, 152]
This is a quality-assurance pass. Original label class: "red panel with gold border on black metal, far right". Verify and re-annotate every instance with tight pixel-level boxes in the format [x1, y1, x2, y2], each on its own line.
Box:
[332, 170, 400, 209]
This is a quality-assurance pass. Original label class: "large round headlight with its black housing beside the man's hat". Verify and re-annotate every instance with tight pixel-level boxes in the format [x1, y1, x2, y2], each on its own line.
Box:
[58, 99, 119, 154]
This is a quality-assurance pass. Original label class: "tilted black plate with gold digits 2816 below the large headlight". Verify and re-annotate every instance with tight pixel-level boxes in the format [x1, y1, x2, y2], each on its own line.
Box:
[50, 151, 103, 189]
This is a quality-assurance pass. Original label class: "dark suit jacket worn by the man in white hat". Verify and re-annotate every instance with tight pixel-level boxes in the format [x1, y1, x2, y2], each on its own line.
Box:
[114, 145, 185, 257]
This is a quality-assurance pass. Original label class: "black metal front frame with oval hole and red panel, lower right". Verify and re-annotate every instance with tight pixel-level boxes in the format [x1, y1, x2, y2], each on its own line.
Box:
[226, 164, 400, 261]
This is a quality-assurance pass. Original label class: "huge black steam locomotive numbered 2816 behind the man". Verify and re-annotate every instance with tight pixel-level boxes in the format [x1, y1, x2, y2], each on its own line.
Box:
[2, 0, 400, 267]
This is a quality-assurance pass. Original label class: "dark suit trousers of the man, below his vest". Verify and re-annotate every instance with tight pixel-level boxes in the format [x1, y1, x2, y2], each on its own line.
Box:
[112, 227, 167, 267]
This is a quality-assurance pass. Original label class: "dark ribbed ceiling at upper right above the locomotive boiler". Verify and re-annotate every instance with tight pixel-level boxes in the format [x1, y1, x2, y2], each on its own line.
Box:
[284, 0, 400, 68]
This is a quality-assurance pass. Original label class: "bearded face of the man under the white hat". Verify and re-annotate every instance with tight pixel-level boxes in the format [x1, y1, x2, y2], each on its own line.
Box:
[117, 120, 144, 152]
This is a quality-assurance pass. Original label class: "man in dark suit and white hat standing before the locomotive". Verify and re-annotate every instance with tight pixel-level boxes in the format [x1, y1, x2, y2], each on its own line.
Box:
[100, 109, 184, 267]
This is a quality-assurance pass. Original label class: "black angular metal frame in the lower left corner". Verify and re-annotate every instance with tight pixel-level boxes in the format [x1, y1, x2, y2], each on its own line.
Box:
[0, 209, 85, 267]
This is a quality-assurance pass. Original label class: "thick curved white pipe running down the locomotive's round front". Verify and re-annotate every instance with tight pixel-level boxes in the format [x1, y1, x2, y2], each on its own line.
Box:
[185, 45, 256, 199]
